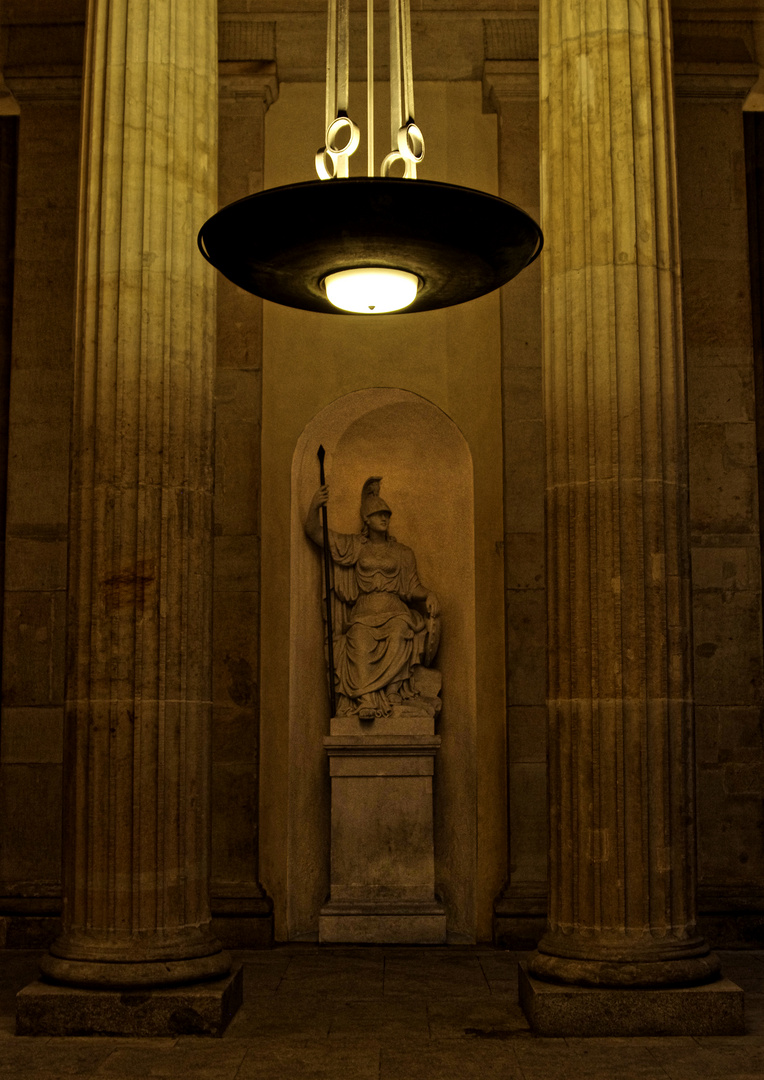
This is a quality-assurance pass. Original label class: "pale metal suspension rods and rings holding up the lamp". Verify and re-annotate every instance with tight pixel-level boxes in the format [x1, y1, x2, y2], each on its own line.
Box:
[316, 0, 425, 180]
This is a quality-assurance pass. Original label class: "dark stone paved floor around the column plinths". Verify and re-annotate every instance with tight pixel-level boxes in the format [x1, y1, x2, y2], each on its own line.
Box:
[0, 945, 764, 1080]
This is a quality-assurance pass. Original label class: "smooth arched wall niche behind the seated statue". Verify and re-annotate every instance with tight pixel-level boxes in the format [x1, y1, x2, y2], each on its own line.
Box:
[286, 389, 477, 941]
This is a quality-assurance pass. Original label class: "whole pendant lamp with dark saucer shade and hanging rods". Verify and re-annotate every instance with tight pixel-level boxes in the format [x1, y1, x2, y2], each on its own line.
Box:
[198, 0, 544, 316]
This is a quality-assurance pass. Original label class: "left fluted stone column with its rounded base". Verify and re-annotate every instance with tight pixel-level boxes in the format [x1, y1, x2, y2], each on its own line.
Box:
[23, 0, 230, 1010]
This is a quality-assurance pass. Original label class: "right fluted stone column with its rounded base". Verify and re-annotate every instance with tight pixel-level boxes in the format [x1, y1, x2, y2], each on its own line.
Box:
[528, 0, 743, 1034]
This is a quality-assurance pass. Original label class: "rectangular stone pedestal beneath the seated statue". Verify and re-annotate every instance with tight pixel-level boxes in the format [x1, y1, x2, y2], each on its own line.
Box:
[319, 706, 446, 945]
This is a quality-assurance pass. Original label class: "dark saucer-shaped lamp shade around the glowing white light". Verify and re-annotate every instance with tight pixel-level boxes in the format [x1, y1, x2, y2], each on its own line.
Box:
[199, 177, 544, 318]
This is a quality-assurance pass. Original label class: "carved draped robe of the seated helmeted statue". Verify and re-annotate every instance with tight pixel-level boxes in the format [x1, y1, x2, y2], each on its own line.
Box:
[329, 529, 427, 715]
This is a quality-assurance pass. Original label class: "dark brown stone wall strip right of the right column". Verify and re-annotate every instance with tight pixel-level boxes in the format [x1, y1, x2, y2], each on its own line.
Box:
[676, 50, 764, 944]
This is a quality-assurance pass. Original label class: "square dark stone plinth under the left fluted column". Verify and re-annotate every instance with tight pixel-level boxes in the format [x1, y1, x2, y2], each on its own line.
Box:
[16, 967, 243, 1038]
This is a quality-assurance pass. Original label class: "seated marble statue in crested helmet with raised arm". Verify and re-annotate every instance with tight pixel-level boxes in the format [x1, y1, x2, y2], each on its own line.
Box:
[305, 476, 440, 720]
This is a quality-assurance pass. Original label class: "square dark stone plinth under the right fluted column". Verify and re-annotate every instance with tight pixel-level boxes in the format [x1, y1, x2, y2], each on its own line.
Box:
[518, 962, 746, 1038]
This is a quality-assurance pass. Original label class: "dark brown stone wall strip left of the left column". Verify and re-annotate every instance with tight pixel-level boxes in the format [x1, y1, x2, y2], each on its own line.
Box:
[0, 68, 80, 944]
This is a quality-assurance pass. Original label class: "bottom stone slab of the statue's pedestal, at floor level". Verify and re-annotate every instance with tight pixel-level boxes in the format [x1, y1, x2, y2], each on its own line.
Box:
[319, 902, 446, 945]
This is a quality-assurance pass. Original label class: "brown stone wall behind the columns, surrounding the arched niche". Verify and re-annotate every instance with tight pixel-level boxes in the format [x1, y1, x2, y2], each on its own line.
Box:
[0, 6, 764, 945]
